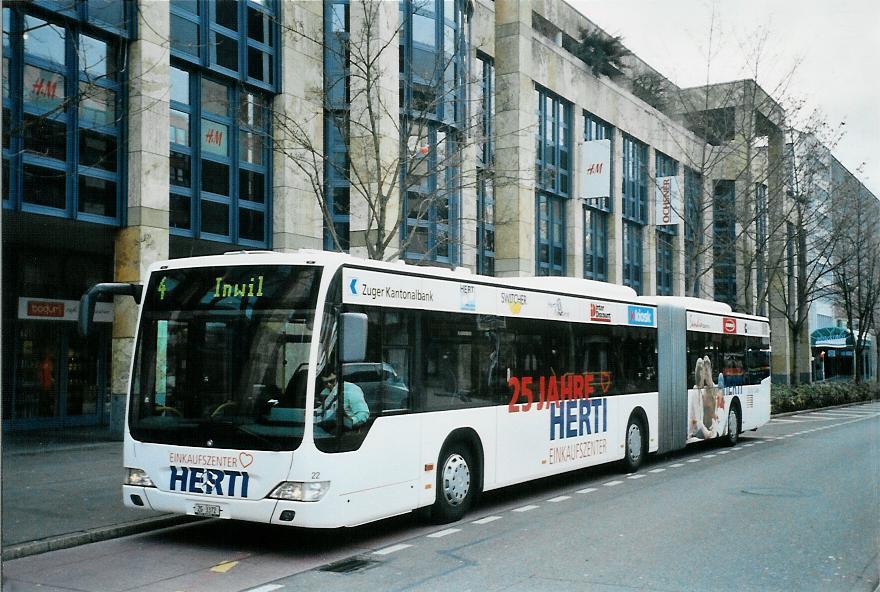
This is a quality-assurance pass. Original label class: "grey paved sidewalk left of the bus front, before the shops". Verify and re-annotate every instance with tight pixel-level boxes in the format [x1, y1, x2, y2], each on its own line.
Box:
[2, 427, 187, 560]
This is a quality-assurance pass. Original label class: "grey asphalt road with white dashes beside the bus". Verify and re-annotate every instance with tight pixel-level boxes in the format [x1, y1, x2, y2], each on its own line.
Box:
[3, 404, 880, 592]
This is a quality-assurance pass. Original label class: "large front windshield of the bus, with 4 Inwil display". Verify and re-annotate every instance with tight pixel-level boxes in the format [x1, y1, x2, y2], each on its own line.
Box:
[129, 266, 321, 451]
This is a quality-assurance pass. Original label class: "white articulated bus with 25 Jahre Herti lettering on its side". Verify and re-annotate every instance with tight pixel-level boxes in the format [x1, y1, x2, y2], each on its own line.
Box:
[81, 251, 770, 527]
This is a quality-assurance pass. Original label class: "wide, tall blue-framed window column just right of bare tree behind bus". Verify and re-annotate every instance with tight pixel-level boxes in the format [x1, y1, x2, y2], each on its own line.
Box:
[399, 0, 468, 264]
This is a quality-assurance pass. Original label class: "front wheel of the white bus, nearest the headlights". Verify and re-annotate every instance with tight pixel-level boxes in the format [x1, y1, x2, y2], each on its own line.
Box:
[431, 442, 477, 524]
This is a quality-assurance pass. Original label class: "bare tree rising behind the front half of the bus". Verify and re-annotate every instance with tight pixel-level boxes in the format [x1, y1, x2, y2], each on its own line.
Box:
[274, 0, 521, 260]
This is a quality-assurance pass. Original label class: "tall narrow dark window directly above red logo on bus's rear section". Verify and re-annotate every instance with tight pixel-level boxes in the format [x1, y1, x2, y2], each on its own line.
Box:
[712, 180, 737, 309]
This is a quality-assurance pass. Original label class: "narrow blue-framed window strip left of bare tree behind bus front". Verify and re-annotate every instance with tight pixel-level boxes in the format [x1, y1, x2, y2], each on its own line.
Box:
[323, 0, 351, 251]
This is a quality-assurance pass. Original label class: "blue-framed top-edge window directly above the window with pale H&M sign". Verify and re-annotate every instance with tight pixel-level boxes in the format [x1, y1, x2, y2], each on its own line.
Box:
[170, 0, 280, 92]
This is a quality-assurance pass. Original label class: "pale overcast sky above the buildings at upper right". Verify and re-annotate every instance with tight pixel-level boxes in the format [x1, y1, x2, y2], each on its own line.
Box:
[567, 0, 880, 197]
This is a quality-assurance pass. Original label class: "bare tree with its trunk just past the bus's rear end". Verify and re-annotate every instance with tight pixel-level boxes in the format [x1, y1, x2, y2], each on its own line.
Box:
[633, 20, 856, 383]
